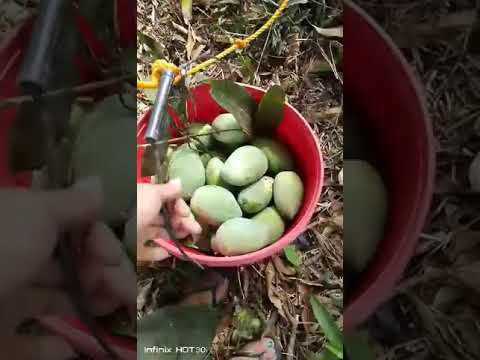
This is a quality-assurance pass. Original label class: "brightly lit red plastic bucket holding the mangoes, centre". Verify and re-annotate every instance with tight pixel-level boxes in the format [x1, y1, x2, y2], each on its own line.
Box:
[137, 84, 324, 267]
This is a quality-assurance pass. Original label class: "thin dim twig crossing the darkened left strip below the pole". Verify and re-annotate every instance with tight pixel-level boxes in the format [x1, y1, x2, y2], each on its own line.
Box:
[0, 75, 134, 109]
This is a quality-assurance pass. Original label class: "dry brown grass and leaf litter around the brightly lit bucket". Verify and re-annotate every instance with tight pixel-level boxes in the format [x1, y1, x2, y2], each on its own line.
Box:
[137, 0, 343, 359]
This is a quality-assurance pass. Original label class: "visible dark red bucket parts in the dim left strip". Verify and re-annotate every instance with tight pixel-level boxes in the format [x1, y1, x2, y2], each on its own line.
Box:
[0, 6, 137, 360]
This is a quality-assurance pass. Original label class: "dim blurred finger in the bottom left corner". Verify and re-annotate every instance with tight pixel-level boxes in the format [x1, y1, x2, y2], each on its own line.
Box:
[0, 336, 77, 360]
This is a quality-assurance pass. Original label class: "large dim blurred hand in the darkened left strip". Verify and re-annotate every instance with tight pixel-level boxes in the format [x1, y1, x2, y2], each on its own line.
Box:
[0, 180, 136, 360]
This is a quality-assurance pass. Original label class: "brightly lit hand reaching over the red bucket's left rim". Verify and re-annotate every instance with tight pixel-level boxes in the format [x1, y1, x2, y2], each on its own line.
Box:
[137, 179, 202, 261]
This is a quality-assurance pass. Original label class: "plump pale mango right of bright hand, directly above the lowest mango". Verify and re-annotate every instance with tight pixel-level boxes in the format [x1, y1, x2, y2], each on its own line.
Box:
[190, 185, 242, 226]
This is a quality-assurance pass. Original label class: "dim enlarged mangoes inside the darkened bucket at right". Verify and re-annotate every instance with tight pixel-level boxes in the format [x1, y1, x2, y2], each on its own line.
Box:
[343, 111, 388, 274]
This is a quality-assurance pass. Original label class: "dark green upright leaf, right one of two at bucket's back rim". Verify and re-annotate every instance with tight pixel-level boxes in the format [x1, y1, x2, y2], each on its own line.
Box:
[253, 85, 285, 136]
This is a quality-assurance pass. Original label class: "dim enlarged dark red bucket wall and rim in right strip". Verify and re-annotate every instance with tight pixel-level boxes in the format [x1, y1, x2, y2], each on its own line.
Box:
[344, 1, 435, 330]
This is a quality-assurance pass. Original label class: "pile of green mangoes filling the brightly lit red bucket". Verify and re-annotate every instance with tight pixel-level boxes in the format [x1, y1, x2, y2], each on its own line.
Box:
[165, 113, 304, 256]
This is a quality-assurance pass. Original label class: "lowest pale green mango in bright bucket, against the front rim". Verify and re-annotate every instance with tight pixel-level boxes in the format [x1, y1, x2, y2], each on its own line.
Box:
[212, 217, 270, 256]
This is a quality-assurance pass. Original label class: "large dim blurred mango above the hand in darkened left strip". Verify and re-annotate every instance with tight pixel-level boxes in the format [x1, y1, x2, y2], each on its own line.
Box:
[72, 95, 137, 225]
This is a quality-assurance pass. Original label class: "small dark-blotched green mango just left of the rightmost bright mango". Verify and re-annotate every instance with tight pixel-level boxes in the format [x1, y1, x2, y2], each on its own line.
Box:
[237, 176, 273, 214]
